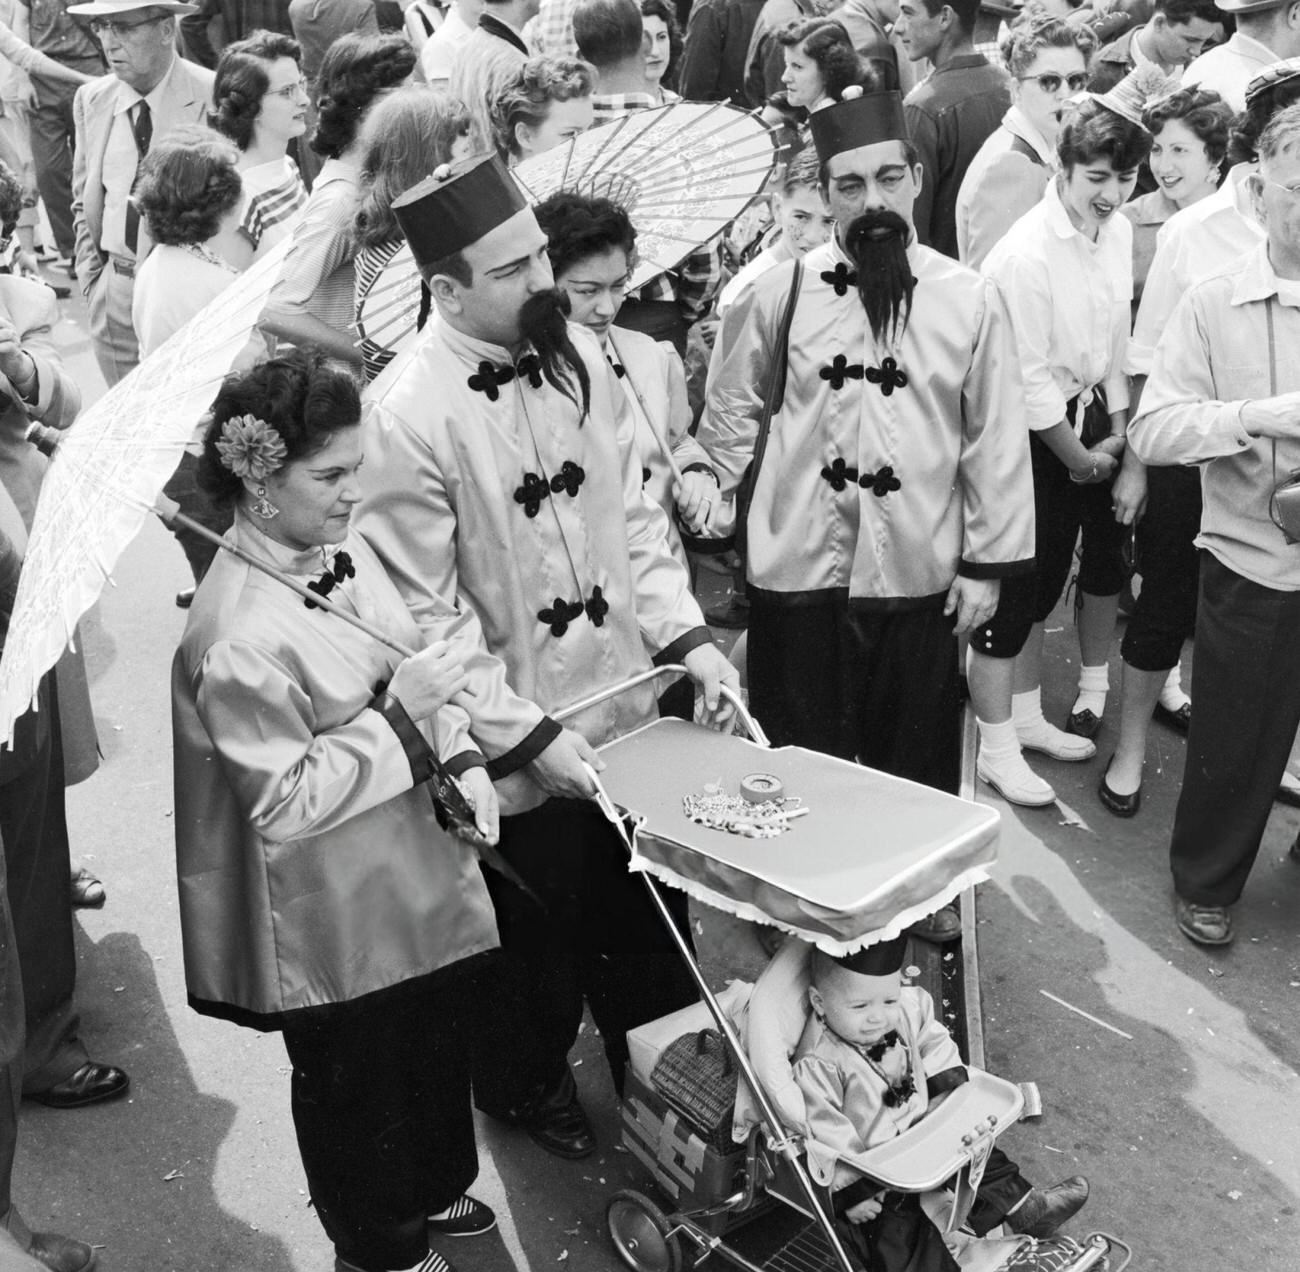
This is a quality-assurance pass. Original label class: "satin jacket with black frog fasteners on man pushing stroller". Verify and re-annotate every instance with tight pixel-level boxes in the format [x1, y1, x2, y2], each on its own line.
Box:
[358, 317, 710, 813]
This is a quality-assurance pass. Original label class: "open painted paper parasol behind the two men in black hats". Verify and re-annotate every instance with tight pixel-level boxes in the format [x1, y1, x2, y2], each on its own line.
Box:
[358, 101, 779, 366]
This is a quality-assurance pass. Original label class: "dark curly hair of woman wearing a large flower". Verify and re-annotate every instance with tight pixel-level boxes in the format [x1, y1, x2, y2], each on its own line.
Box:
[196, 349, 361, 507]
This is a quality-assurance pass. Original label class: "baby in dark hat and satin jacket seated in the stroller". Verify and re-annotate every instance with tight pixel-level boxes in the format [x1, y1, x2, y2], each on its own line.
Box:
[793, 938, 1088, 1272]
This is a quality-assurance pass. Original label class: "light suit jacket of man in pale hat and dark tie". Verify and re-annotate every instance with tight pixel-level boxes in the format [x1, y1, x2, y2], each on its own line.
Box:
[73, 57, 213, 293]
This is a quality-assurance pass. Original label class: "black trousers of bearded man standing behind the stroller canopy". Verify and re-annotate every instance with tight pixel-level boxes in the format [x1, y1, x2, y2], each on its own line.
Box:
[749, 592, 961, 793]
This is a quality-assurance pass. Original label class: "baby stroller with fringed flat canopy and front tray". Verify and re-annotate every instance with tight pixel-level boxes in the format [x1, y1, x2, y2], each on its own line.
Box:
[564, 667, 1132, 1272]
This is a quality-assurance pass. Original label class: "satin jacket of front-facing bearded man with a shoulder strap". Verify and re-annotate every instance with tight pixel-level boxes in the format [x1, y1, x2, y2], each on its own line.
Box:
[697, 239, 1034, 609]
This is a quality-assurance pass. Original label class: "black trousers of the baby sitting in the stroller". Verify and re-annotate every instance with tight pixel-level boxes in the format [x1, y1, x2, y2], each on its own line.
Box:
[836, 1148, 1031, 1272]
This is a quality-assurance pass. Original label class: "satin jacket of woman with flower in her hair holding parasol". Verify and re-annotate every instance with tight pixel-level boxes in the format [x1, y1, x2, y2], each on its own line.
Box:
[172, 515, 497, 1029]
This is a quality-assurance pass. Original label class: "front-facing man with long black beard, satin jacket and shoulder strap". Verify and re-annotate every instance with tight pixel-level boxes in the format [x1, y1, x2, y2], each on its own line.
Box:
[698, 92, 1034, 920]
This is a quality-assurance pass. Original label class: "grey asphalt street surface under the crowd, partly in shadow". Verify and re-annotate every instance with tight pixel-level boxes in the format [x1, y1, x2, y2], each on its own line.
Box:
[14, 282, 1300, 1272]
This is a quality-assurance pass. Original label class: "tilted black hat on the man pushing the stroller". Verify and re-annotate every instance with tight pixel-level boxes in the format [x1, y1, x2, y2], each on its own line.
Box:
[393, 155, 528, 269]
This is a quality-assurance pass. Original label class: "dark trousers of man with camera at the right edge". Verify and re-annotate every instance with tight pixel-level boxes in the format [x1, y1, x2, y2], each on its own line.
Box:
[1170, 554, 1300, 905]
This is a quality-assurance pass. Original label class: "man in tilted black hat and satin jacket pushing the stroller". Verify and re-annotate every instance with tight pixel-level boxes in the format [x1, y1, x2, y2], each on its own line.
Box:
[360, 156, 736, 1156]
